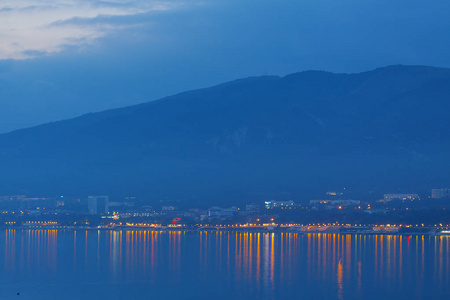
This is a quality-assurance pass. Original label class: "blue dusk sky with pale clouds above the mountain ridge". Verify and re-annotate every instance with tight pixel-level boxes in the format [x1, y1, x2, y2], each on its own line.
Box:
[0, 0, 450, 133]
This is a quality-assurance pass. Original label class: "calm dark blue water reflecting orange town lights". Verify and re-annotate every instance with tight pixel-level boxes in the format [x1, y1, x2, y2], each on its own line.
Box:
[0, 230, 450, 300]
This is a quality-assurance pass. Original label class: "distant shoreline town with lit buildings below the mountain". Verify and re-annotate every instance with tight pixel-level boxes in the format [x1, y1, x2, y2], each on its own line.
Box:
[0, 188, 450, 235]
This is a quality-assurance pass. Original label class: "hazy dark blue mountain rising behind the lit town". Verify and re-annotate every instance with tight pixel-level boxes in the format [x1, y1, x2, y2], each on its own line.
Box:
[0, 66, 450, 203]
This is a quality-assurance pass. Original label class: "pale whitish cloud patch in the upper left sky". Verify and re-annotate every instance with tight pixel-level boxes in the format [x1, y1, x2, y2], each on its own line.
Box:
[0, 0, 192, 59]
